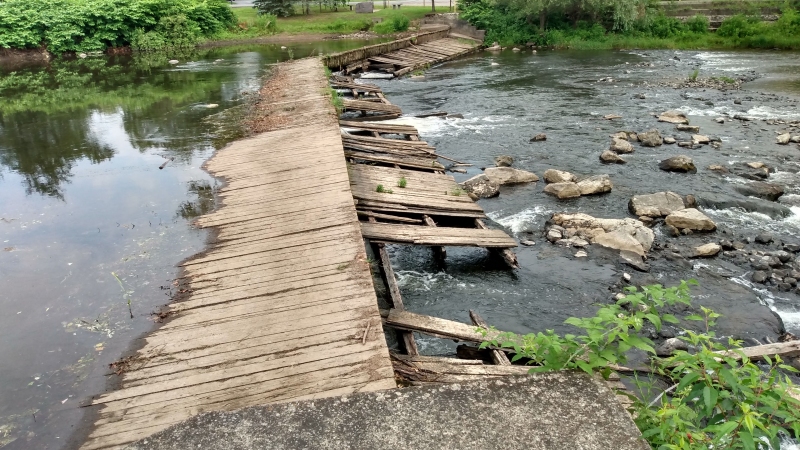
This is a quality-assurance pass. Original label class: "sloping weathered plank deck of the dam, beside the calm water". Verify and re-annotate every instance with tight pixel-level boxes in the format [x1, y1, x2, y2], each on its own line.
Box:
[82, 59, 396, 450]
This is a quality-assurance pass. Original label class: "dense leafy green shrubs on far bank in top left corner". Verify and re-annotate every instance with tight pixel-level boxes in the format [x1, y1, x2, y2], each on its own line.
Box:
[0, 0, 235, 54]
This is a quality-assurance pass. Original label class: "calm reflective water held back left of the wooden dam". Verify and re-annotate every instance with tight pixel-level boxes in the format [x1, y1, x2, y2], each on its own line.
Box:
[0, 41, 382, 448]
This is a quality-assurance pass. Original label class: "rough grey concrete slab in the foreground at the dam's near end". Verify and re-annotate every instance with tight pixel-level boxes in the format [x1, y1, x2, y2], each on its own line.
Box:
[128, 372, 650, 450]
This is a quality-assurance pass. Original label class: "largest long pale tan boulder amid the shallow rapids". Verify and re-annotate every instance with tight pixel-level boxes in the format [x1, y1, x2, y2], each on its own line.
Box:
[551, 213, 655, 256]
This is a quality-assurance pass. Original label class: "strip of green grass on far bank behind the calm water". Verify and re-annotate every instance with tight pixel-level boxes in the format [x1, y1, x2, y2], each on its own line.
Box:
[216, 5, 449, 40]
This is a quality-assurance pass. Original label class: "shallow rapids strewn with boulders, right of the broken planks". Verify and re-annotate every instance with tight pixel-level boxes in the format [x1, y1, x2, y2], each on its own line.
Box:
[372, 50, 800, 353]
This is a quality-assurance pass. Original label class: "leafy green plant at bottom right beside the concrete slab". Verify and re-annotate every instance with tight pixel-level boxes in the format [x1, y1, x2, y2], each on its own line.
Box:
[481, 280, 800, 450]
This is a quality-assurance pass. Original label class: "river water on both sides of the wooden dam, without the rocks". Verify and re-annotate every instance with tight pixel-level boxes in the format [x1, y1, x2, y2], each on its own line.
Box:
[0, 41, 800, 448]
